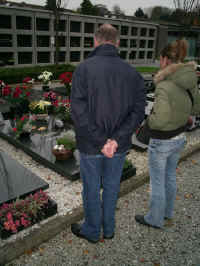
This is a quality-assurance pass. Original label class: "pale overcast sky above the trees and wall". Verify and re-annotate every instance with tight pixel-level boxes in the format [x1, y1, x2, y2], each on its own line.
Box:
[10, 0, 174, 15]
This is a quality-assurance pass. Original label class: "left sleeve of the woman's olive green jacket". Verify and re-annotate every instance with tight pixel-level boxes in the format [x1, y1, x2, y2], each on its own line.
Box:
[148, 83, 170, 130]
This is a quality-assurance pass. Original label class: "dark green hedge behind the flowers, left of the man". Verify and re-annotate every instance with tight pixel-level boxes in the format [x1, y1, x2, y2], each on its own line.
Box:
[0, 64, 75, 84]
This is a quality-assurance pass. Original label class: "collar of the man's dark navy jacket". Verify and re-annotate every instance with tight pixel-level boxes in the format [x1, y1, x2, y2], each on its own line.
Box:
[88, 44, 119, 57]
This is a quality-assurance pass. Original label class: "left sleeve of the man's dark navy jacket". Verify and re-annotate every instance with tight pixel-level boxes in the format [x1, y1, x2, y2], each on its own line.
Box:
[71, 65, 106, 150]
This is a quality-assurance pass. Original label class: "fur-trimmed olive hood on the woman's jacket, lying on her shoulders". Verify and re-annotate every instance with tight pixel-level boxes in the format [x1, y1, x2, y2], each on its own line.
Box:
[154, 61, 197, 89]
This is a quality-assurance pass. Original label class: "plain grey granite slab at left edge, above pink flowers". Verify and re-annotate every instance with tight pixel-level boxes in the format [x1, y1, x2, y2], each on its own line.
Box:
[0, 150, 49, 204]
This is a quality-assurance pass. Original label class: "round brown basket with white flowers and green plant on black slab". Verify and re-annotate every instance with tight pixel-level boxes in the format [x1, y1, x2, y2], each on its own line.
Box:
[52, 136, 76, 161]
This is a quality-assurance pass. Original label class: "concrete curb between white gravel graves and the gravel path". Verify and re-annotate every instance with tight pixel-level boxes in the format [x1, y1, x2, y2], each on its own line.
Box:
[0, 143, 200, 266]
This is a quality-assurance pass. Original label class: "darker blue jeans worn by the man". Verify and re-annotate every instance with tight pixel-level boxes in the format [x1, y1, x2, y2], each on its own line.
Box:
[80, 153, 126, 240]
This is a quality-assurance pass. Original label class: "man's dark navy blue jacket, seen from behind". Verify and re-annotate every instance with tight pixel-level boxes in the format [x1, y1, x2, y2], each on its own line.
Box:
[71, 44, 146, 154]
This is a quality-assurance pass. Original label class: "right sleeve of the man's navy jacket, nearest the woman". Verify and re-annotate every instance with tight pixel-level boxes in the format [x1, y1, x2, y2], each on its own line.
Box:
[112, 74, 146, 142]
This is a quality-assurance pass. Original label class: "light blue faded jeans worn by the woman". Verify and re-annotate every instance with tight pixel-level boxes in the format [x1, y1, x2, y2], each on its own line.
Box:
[144, 137, 186, 228]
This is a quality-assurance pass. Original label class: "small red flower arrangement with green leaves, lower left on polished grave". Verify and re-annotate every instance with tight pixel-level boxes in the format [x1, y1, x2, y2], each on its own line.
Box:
[13, 115, 34, 138]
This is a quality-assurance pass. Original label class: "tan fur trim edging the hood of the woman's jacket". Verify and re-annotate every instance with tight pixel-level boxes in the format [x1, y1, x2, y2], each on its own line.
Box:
[153, 61, 197, 84]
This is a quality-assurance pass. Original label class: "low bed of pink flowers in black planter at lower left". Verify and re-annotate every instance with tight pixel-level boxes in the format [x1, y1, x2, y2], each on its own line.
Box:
[0, 190, 57, 239]
